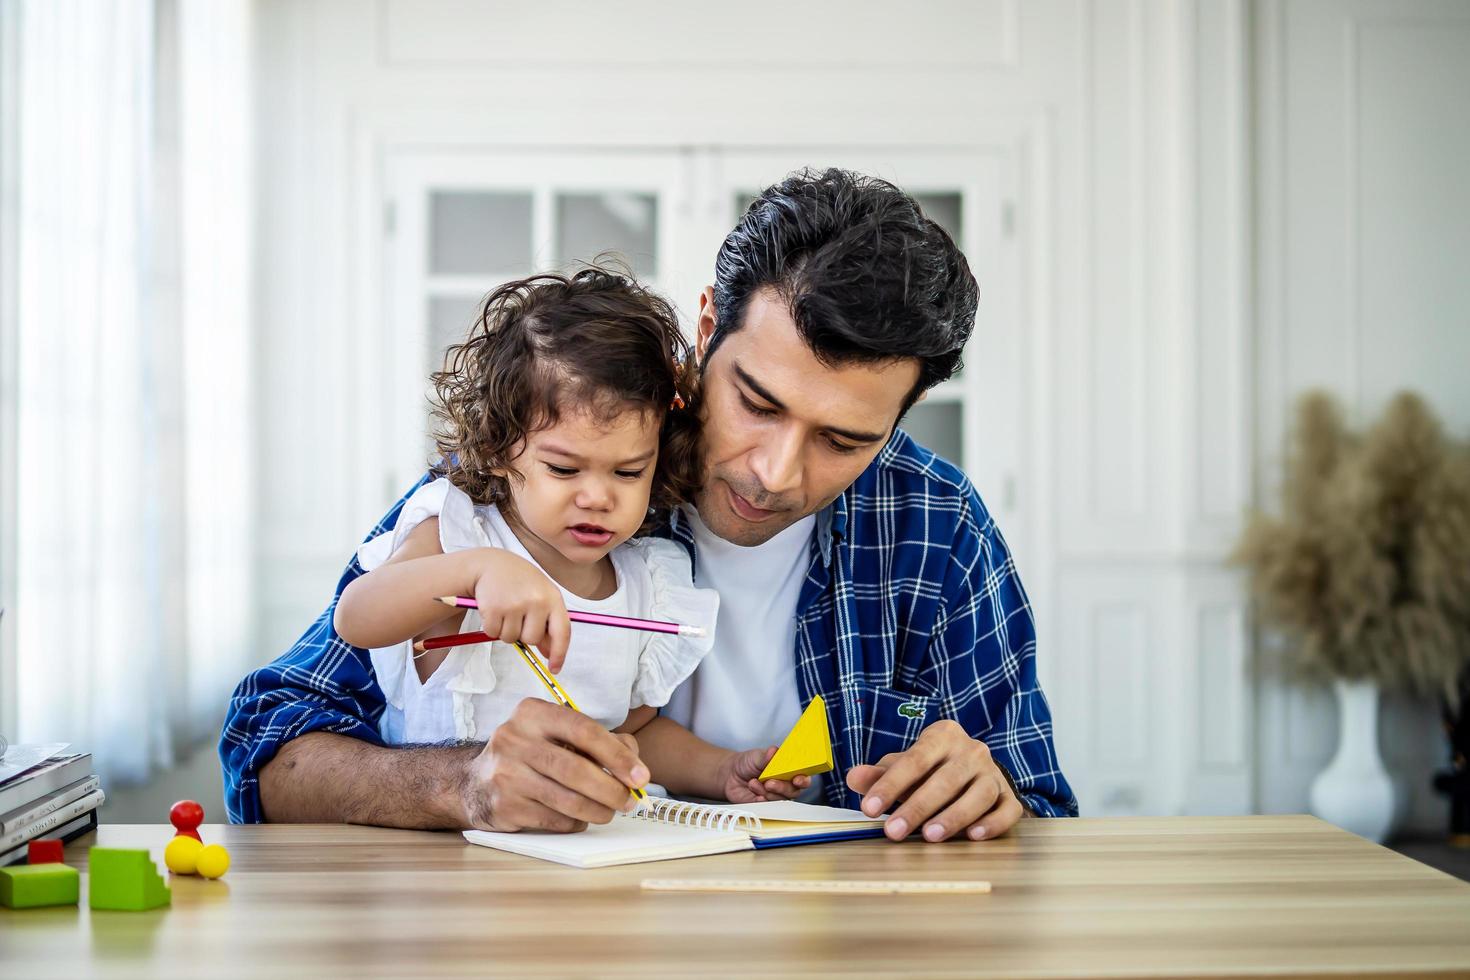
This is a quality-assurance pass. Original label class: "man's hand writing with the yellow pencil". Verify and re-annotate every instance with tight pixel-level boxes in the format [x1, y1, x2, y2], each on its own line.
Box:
[460, 698, 648, 833]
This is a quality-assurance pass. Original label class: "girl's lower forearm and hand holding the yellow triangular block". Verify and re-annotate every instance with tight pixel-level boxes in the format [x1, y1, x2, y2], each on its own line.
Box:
[617, 707, 811, 804]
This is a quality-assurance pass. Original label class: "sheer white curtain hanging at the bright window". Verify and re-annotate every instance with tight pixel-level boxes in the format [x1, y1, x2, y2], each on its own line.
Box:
[10, 0, 253, 785]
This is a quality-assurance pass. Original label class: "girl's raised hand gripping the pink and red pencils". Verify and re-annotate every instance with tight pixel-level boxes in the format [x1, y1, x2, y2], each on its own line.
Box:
[475, 548, 572, 673]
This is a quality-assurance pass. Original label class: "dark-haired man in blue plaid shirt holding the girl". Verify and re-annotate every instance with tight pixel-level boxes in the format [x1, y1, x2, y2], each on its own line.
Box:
[219, 170, 1078, 842]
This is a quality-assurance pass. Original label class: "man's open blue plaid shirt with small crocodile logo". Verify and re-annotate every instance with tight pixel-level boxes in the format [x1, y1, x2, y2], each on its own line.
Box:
[219, 430, 1078, 823]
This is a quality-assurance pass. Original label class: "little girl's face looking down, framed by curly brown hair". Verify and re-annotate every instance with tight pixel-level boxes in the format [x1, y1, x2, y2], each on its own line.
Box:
[510, 410, 662, 577]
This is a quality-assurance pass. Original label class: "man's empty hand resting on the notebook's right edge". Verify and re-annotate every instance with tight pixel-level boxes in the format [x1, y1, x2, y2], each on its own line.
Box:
[847, 721, 1026, 842]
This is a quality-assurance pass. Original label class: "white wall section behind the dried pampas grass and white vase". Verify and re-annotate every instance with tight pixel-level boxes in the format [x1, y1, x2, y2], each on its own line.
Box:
[1255, 0, 1470, 832]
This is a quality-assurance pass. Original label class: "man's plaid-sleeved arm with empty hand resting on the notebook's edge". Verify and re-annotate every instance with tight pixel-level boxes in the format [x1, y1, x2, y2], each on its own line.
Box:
[847, 502, 1078, 840]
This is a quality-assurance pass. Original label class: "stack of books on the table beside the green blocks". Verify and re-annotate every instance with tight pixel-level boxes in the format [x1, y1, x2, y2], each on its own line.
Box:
[0, 745, 103, 867]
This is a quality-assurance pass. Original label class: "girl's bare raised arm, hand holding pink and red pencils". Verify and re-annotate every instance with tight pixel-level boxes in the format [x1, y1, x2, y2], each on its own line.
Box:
[332, 517, 570, 670]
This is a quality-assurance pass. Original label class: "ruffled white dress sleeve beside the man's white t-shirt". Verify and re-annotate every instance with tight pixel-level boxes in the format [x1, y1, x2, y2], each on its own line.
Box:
[625, 538, 720, 708]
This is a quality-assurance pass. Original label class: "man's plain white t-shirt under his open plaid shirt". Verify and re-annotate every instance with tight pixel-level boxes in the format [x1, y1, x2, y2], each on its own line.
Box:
[663, 507, 817, 796]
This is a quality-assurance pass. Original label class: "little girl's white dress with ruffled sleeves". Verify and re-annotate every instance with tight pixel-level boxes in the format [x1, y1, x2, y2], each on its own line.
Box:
[357, 479, 719, 745]
